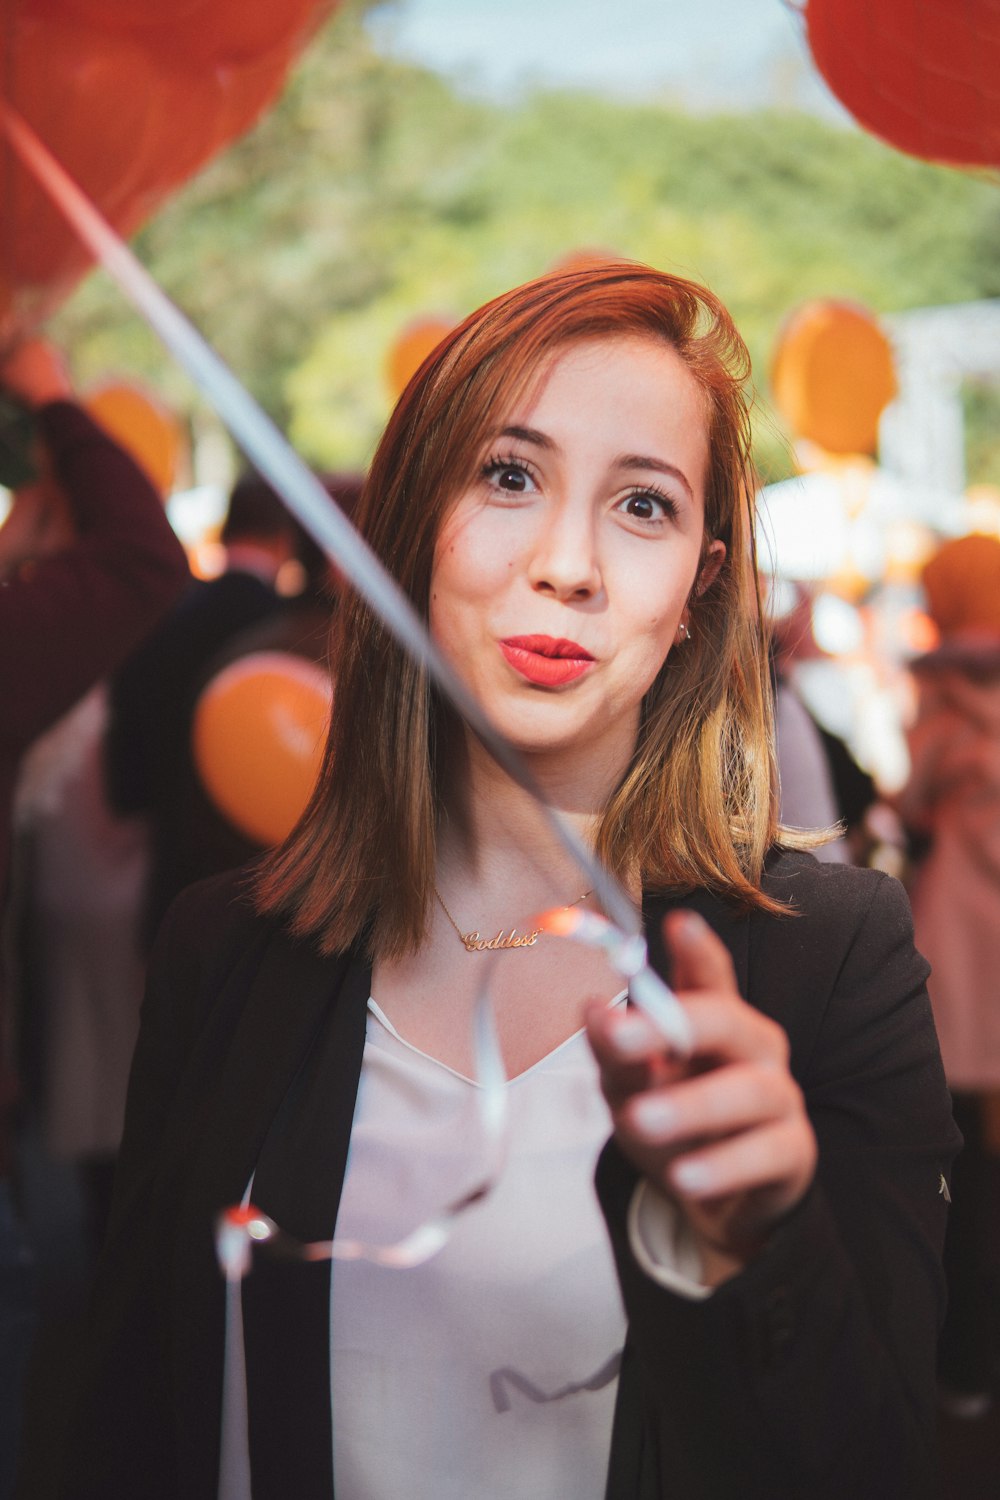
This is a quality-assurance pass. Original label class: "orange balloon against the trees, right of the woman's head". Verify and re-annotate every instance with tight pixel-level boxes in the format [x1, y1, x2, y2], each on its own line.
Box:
[771, 299, 897, 453]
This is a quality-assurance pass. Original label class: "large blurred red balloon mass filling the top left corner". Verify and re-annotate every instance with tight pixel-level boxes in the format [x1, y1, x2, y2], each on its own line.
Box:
[0, 0, 336, 327]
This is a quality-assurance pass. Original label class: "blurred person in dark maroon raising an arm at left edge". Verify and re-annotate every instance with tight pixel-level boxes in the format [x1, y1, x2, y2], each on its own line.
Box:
[0, 341, 189, 1497]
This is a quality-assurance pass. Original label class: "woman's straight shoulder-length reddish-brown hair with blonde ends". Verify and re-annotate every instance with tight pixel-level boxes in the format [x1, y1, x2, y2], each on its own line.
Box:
[255, 261, 803, 956]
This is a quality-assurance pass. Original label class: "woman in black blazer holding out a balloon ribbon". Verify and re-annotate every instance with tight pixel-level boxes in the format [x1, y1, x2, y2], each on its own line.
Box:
[58, 263, 955, 1500]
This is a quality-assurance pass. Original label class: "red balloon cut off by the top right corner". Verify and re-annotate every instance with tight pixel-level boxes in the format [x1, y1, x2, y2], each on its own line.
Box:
[805, 0, 1000, 167]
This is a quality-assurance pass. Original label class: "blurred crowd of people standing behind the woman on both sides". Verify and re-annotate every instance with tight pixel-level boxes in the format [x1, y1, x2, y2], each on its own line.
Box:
[0, 313, 1000, 1494]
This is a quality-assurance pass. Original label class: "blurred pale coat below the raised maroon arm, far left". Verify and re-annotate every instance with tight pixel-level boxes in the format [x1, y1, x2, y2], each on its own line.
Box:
[10, 657, 148, 1251]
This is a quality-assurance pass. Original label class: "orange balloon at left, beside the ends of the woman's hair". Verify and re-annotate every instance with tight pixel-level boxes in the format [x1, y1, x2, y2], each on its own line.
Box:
[192, 651, 333, 845]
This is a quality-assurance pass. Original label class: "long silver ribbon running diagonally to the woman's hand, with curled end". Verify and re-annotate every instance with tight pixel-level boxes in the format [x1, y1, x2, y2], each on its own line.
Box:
[0, 102, 704, 1494]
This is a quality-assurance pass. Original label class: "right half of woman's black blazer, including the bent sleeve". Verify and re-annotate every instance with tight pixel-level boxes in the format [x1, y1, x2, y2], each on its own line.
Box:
[597, 866, 958, 1500]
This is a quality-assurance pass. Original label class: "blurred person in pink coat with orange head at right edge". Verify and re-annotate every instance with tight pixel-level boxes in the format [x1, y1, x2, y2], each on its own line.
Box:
[894, 536, 1000, 1418]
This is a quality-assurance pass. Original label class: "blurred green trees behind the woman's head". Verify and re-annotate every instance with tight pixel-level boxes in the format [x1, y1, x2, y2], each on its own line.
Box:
[57, 0, 1000, 480]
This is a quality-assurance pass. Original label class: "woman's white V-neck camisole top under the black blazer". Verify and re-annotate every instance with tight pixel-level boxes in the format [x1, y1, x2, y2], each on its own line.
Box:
[330, 993, 625, 1500]
